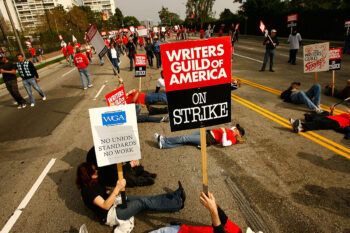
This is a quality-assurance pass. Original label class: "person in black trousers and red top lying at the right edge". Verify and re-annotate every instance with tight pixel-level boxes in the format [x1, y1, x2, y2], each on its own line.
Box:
[289, 112, 350, 138]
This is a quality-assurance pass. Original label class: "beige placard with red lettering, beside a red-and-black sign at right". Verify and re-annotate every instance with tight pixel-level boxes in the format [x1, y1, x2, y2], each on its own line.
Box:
[303, 42, 329, 73]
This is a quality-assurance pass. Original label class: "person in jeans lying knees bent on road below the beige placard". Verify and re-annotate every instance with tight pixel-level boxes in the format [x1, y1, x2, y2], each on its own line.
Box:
[280, 82, 322, 113]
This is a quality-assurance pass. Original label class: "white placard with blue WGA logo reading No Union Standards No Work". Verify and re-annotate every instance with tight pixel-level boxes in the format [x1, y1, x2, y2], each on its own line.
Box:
[89, 104, 141, 167]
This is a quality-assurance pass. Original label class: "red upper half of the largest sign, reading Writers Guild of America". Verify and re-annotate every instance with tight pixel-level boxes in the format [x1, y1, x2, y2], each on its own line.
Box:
[160, 36, 232, 92]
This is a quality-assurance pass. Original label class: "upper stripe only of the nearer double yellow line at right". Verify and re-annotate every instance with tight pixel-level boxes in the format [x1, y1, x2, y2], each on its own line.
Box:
[233, 95, 350, 154]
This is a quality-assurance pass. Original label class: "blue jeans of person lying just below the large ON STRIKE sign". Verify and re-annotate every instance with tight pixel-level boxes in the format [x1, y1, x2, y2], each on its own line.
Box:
[161, 131, 201, 149]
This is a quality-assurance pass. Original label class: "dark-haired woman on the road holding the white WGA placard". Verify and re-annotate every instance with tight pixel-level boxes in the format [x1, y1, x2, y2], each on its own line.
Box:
[76, 163, 186, 232]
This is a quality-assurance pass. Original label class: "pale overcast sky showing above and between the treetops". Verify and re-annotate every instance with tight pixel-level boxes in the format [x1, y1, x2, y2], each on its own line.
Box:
[116, 0, 239, 22]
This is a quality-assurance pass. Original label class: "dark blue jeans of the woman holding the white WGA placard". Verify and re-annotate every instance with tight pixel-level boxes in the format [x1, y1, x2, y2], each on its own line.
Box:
[117, 190, 182, 220]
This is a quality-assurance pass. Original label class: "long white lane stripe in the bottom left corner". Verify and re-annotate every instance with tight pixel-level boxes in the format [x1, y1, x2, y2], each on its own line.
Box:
[1, 159, 56, 233]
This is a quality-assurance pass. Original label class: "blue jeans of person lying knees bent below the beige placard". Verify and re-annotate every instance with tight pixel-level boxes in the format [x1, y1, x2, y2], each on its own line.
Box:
[290, 84, 321, 110]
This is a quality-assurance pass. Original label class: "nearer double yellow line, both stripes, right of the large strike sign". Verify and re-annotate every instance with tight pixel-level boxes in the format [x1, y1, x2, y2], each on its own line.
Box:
[232, 95, 350, 159]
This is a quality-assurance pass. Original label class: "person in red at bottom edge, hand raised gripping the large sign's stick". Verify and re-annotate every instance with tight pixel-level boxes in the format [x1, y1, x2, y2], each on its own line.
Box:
[150, 192, 242, 233]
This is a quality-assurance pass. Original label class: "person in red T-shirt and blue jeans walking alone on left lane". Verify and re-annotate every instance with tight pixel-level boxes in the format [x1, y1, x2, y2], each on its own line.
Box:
[73, 48, 92, 90]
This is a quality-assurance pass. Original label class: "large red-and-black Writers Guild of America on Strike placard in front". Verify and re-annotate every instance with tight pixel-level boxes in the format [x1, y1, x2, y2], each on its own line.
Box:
[161, 37, 232, 131]
